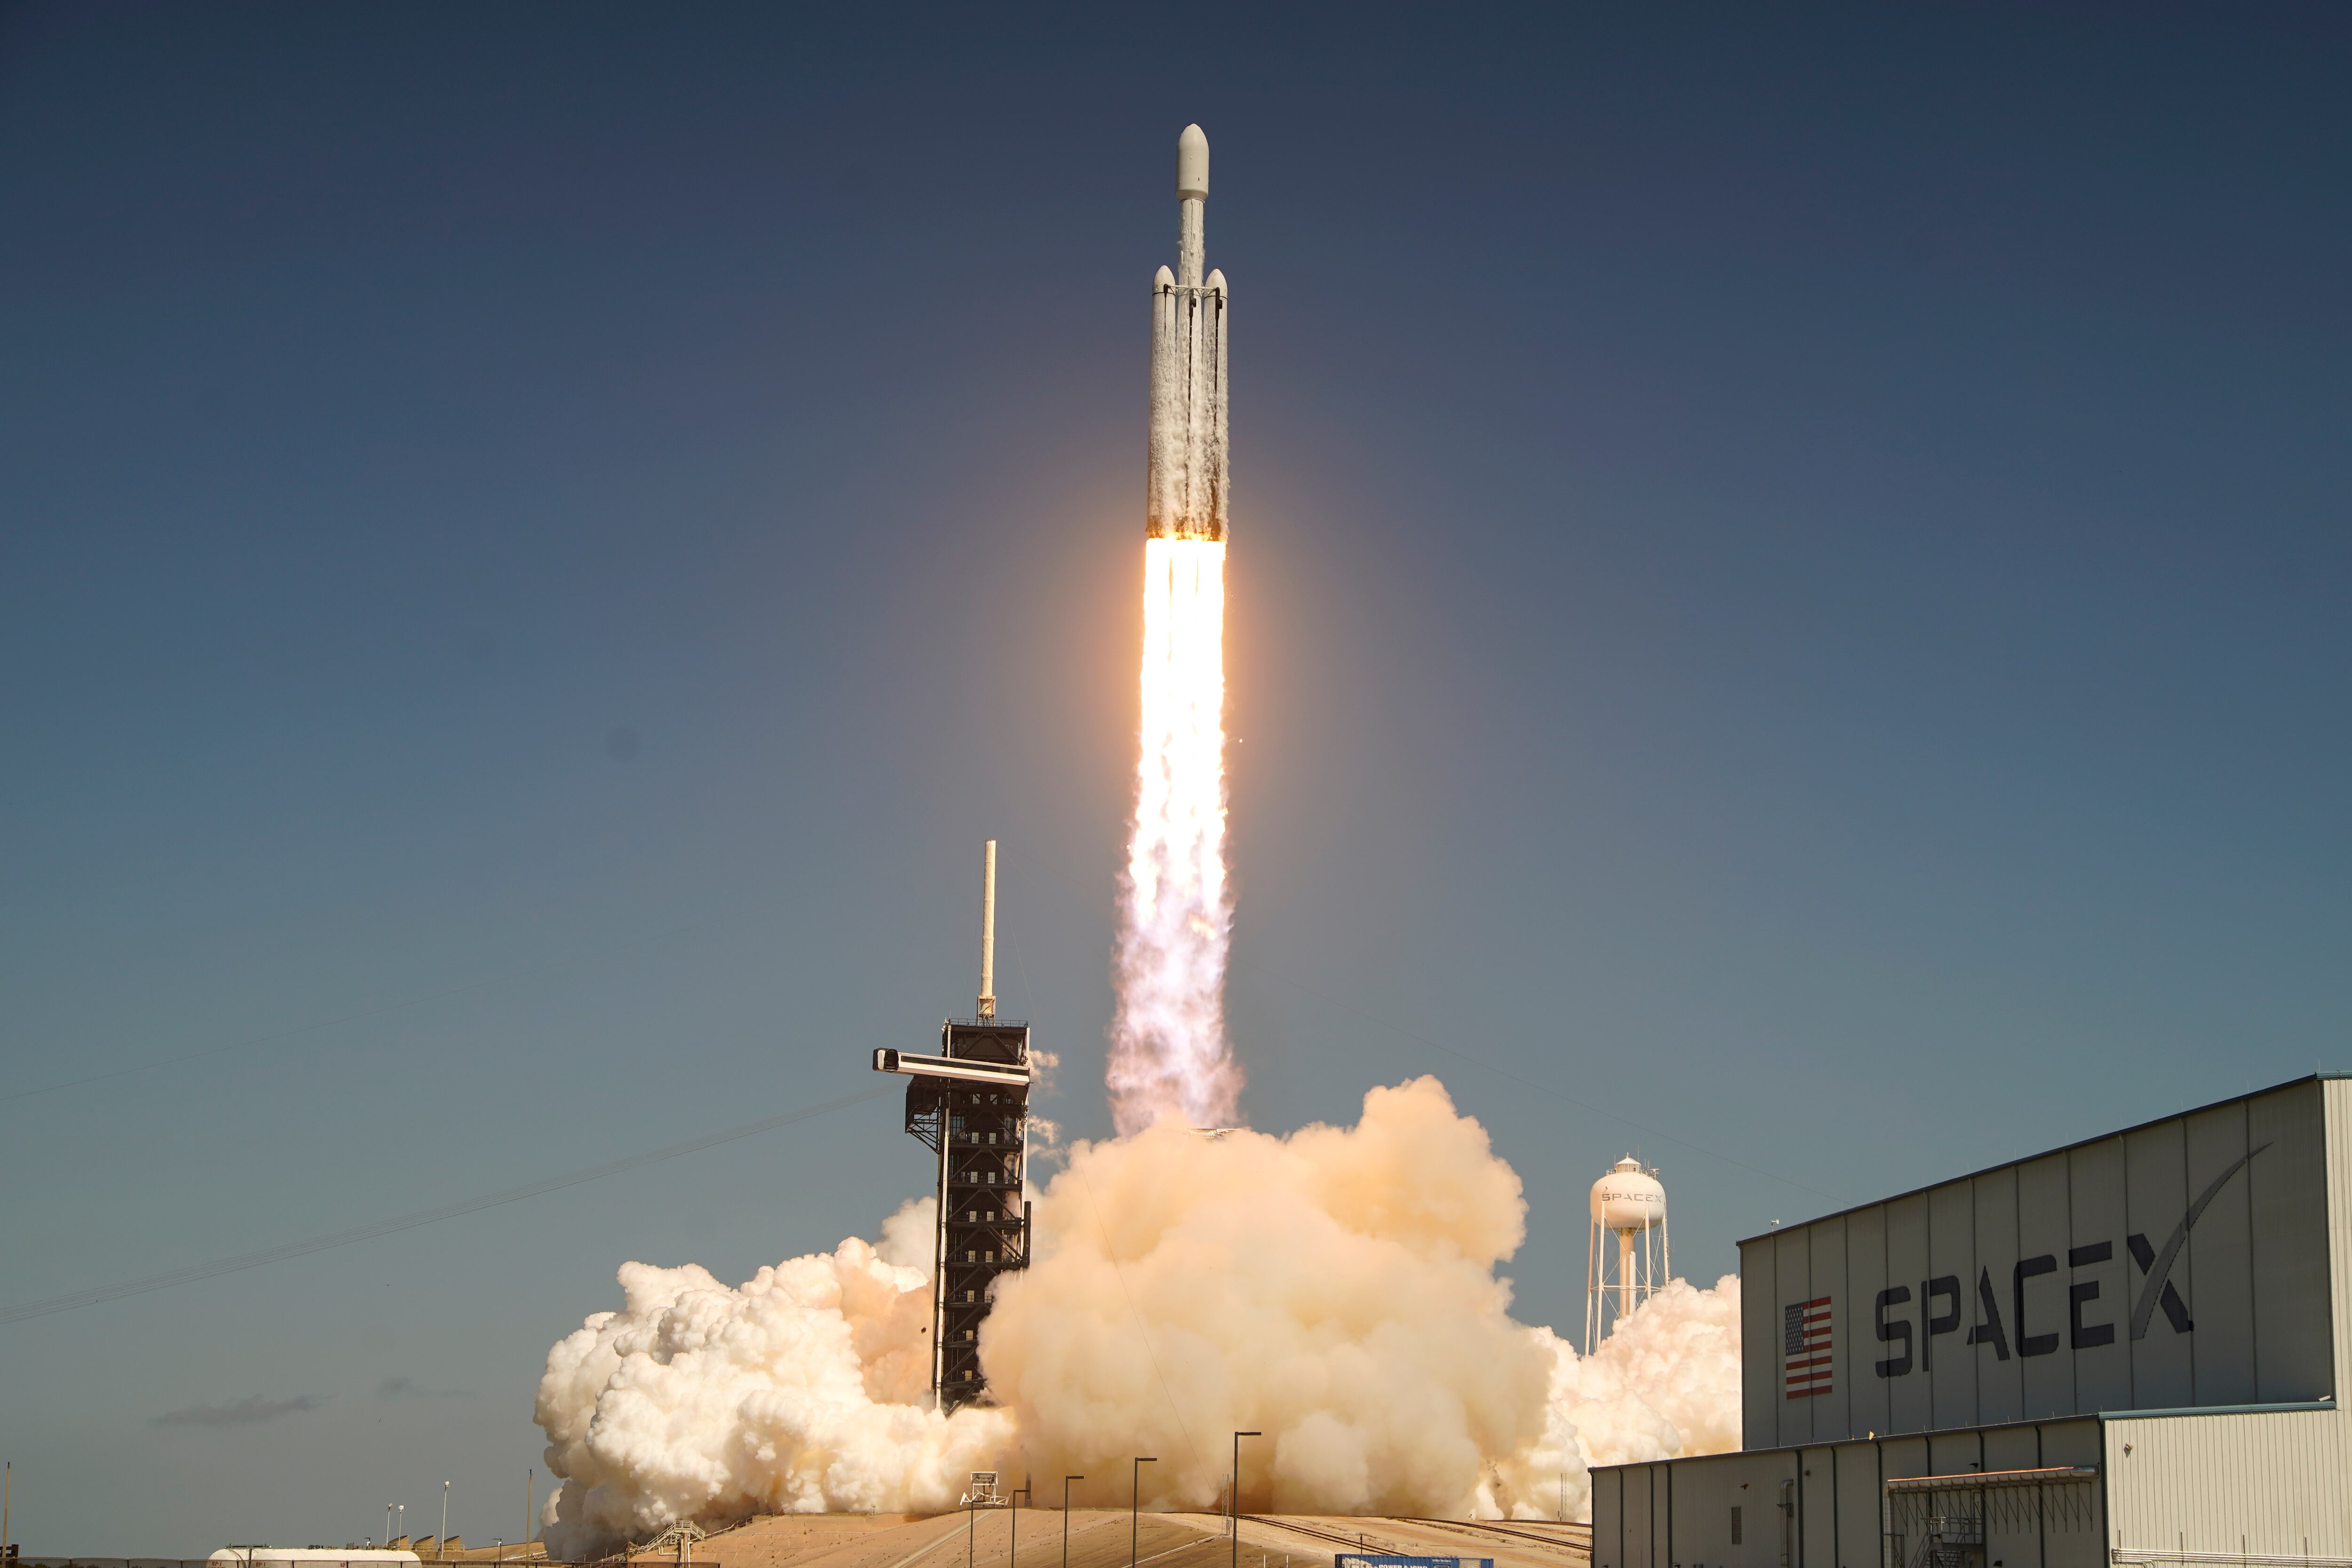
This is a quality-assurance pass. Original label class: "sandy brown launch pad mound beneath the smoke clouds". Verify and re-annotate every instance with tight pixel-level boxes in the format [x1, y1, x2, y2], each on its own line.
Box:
[654, 1509, 1592, 1568]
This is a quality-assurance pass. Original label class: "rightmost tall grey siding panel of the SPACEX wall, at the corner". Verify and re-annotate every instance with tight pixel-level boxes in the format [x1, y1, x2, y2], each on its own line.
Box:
[2246, 1084, 2336, 1403]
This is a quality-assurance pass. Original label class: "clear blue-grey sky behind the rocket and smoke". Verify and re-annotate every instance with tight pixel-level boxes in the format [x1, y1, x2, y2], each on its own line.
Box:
[0, 5, 2352, 1556]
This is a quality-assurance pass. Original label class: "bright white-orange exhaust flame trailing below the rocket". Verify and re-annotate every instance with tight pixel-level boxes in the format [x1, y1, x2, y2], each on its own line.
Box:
[1105, 539, 1242, 1133]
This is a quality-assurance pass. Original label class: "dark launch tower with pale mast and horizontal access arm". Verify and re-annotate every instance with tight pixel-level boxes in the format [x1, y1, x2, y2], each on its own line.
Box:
[875, 839, 1033, 1410]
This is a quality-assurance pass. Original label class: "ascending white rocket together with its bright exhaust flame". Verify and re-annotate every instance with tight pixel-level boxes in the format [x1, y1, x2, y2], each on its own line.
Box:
[1105, 125, 1242, 1133]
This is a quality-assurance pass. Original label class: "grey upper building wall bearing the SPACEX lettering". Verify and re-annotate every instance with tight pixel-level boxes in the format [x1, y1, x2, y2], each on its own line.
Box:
[1740, 1079, 2324, 1448]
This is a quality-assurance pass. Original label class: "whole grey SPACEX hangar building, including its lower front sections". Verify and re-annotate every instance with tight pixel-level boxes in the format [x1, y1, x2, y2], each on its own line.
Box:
[1592, 1077, 2352, 1568]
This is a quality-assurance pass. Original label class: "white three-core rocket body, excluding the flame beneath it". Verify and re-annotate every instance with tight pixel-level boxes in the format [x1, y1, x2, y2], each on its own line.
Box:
[1143, 125, 1228, 541]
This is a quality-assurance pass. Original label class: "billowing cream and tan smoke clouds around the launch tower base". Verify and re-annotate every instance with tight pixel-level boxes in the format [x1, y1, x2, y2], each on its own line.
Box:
[539, 1079, 1740, 1559]
